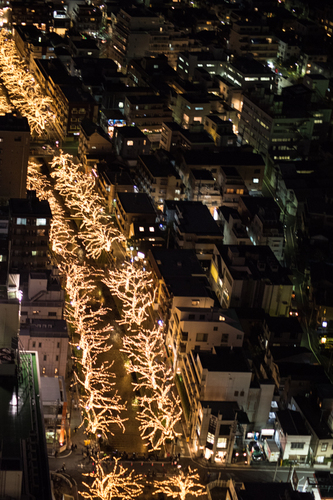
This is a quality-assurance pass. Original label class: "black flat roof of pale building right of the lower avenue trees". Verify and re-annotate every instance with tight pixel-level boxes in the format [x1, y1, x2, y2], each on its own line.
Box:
[192, 346, 251, 373]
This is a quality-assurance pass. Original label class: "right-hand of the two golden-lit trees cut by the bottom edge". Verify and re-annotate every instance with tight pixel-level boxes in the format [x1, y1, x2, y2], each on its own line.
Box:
[154, 467, 206, 500]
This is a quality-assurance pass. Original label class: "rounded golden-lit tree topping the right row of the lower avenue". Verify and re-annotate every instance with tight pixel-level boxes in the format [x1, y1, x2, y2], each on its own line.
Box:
[103, 263, 156, 328]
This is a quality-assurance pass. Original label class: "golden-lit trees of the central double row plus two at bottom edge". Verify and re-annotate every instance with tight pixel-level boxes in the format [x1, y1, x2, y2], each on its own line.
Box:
[28, 155, 203, 500]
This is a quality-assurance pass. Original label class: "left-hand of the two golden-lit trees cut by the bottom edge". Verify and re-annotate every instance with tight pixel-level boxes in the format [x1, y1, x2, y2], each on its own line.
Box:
[80, 458, 144, 500]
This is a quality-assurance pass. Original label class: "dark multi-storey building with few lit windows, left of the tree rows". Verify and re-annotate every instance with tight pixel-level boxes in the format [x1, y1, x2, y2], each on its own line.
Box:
[9, 191, 52, 272]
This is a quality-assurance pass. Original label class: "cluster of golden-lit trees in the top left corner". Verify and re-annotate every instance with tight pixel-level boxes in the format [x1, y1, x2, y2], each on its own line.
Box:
[0, 30, 55, 135]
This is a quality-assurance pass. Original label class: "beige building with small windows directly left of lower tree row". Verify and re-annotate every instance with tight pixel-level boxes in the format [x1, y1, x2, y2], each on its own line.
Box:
[20, 319, 69, 378]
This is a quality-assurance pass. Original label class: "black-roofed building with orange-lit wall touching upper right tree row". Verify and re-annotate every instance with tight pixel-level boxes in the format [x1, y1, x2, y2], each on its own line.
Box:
[115, 192, 157, 238]
